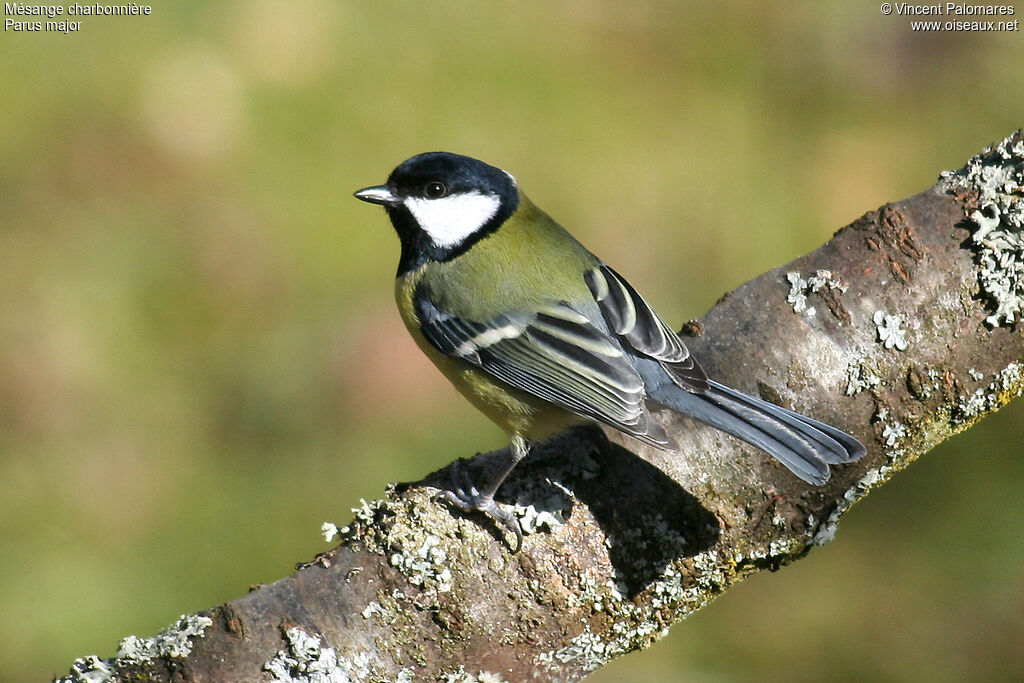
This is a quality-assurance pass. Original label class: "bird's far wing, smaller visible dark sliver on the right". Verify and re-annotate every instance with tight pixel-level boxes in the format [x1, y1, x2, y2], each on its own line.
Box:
[584, 263, 708, 393]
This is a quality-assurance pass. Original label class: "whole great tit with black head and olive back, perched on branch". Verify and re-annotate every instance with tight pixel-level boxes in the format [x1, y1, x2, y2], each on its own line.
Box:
[355, 152, 864, 549]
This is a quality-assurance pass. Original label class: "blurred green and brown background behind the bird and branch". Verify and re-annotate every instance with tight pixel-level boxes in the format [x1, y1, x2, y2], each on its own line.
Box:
[0, 0, 1024, 682]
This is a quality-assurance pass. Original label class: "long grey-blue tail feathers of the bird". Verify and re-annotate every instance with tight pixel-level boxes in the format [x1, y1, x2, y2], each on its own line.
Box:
[650, 381, 865, 484]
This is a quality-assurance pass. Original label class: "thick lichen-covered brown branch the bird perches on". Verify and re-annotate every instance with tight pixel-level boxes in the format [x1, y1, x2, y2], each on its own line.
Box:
[58, 131, 1024, 681]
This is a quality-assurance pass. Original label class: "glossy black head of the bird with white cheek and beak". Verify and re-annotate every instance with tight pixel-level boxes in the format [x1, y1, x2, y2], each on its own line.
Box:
[355, 152, 519, 274]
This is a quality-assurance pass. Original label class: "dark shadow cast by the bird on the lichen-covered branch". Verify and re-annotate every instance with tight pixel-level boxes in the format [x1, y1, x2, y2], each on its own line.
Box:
[415, 426, 721, 598]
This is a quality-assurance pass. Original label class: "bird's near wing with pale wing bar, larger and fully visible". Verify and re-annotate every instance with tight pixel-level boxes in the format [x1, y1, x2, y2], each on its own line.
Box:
[414, 289, 672, 447]
